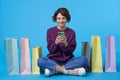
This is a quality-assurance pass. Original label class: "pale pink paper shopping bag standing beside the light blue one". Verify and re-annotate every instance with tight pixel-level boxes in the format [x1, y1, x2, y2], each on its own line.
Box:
[20, 38, 31, 74]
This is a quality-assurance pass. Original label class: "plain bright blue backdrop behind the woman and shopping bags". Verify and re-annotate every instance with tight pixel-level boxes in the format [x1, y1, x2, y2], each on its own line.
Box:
[0, 0, 120, 80]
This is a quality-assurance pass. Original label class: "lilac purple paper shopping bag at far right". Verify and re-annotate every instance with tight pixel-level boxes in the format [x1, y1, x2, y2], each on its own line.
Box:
[105, 36, 116, 72]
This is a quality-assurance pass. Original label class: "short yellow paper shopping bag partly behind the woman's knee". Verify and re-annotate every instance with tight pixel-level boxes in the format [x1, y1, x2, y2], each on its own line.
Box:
[32, 46, 42, 74]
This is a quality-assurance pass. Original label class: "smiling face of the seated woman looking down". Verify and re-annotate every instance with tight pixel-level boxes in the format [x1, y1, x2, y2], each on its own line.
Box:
[56, 13, 67, 27]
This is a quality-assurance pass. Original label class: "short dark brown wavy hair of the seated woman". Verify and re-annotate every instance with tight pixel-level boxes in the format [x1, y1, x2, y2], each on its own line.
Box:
[52, 8, 71, 22]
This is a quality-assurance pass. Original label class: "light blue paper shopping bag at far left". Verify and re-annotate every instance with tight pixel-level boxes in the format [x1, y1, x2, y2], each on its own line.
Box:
[5, 38, 19, 75]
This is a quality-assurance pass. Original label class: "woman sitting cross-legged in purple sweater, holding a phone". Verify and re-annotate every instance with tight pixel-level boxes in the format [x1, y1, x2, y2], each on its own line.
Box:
[38, 8, 88, 76]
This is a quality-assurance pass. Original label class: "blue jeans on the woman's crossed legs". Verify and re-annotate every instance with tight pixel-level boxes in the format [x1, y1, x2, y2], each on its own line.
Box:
[37, 56, 88, 71]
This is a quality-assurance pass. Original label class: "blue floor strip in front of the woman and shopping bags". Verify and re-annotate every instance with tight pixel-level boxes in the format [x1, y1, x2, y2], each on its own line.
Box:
[0, 65, 120, 80]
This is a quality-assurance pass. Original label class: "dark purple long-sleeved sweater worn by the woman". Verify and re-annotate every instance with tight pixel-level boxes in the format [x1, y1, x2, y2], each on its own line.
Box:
[47, 26, 76, 62]
